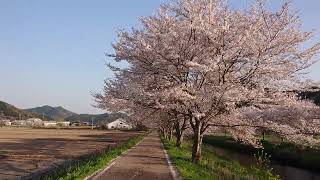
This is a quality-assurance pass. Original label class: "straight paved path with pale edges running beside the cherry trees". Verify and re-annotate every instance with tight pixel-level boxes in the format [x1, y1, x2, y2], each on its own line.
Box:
[93, 132, 174, 180]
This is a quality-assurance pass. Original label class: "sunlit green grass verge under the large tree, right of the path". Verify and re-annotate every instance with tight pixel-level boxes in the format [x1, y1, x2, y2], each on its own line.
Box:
[162, 138, 279, 180]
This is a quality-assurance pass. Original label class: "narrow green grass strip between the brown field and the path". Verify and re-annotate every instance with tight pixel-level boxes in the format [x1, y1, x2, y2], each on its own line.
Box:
[40, 135, 144, 180]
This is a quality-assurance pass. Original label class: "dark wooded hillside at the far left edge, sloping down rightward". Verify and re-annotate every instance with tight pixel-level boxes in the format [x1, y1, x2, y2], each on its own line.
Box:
[0, 101, 50, 120]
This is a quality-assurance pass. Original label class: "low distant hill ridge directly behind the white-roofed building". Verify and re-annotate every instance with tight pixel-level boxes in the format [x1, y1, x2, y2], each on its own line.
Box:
[66, 113, 126, 125]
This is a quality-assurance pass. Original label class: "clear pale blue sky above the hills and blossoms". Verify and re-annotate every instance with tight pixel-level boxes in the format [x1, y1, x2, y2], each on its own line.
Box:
[0, 0, 320, 113]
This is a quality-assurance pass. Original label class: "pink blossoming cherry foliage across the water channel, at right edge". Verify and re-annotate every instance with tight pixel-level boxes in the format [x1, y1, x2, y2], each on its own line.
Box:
[232, 99, 320, 146]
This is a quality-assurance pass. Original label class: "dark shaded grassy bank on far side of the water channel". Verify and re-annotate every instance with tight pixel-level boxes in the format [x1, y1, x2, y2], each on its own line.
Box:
[203, 136, 320, 171]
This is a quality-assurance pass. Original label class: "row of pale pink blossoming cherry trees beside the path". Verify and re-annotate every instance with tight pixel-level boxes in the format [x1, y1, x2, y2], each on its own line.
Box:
[94, 0, 320, 163]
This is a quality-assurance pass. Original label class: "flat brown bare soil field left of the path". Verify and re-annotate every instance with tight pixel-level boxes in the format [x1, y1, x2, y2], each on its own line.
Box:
[0, 128, 138, 179]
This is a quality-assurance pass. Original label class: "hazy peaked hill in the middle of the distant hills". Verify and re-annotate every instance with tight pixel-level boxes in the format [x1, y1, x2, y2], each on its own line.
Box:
[25, 106, 77, 120]
